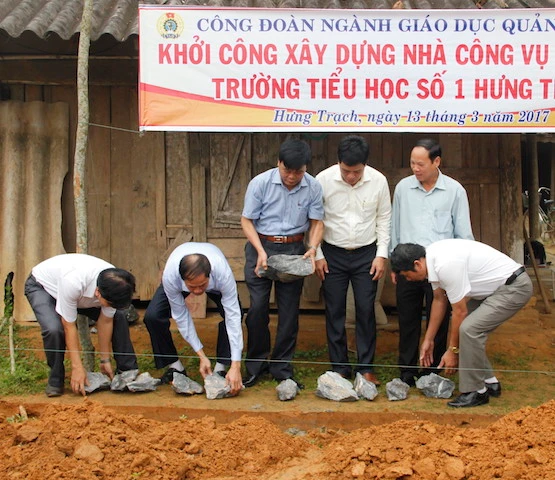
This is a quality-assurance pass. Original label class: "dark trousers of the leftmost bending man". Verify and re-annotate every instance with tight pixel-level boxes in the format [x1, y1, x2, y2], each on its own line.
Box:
[25, 275, 138, 387]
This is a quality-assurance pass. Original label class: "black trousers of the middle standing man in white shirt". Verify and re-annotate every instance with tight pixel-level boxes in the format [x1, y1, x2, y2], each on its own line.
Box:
[322, 242, 378, 378]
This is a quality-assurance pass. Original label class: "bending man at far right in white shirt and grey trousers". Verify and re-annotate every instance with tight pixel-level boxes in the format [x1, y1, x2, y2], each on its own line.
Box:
[391, 239, 533, 407]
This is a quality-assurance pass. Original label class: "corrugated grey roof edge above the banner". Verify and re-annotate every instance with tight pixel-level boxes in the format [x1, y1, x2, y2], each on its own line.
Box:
[0, 0, 555, 42]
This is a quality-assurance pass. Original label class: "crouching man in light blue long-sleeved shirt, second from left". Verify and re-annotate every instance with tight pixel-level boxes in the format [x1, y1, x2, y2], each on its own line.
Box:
[144, 242, 243, 395]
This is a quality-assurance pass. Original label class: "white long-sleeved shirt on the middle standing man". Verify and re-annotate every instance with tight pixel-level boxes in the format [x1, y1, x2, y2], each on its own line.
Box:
[316, 164, 391, 259]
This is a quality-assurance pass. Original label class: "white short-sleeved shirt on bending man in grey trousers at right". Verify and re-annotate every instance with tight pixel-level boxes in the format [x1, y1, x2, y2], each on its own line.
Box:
[426, 239, 521, 304]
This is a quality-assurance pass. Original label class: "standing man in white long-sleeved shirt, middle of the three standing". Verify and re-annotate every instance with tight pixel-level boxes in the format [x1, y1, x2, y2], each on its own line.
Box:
[316, 135, 391, 385]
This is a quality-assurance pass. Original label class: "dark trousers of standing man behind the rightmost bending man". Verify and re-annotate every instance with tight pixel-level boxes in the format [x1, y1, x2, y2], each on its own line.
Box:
[396, 275, 451, 376]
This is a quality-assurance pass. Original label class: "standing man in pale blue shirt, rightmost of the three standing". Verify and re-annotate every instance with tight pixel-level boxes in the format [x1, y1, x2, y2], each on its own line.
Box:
[391, 139, 474, 386]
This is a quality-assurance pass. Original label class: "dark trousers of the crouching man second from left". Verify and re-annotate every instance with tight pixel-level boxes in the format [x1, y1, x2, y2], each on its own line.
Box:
[144, 285, 231, 368]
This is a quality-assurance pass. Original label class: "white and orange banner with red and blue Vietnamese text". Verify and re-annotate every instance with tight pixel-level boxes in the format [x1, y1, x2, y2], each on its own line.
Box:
[139, 6, 555, 132]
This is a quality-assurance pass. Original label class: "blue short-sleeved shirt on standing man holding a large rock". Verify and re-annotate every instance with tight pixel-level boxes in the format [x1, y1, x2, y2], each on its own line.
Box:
[242, 168, 324, 235]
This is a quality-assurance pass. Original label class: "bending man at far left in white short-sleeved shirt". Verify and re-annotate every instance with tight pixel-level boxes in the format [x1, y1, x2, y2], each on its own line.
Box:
[25, 253, 138, 397]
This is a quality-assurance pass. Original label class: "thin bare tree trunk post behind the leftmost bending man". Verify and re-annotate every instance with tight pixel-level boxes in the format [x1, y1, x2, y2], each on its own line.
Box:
[73, 0, 94, 371]
